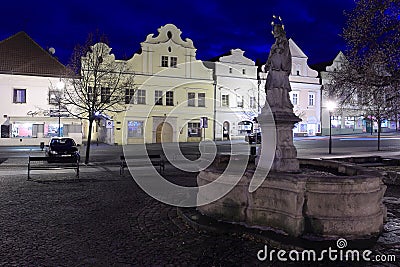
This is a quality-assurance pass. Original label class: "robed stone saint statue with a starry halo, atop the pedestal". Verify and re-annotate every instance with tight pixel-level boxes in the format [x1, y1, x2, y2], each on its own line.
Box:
[265, 18, 293, 109]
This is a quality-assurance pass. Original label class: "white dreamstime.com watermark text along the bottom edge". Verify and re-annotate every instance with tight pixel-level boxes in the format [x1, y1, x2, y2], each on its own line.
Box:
[257, 238, 396, 262]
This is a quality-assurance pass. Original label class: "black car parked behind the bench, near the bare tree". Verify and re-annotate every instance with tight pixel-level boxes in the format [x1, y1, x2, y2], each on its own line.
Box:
[46, 137, 81, 162]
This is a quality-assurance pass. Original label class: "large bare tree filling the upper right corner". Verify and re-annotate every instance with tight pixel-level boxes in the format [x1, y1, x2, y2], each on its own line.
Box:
[329, 0, 400, 150]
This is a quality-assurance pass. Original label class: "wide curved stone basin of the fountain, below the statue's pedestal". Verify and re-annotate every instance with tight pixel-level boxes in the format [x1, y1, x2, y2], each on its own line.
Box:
[197, 156, 386, 239]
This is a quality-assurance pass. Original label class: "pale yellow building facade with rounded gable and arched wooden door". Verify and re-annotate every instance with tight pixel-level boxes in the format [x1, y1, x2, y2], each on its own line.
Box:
[113, 24, 215, 145]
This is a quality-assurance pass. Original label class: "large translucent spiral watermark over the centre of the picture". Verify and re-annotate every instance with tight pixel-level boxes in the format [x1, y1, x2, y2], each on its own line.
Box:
[123, 61, 276, 207]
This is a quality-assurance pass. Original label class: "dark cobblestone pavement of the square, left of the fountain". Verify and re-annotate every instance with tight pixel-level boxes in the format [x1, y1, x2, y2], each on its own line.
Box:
[0, 166, 400, 266]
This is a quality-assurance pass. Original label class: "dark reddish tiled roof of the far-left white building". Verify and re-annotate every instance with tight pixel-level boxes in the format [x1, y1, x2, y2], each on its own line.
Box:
[0, 32, 66, 77]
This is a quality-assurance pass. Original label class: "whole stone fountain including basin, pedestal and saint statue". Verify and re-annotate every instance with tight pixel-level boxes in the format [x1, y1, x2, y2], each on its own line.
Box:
[197, 20, 386, 239]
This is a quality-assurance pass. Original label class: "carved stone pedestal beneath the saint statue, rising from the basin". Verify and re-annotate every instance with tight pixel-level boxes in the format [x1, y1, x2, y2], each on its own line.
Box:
[257, 107, 300, 172]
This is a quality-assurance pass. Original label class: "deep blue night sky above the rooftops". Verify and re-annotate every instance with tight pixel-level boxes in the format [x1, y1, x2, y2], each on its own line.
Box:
[0, 0, 355, 64]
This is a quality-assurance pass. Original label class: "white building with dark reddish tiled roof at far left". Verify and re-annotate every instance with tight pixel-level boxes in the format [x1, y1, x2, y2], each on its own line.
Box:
[0, 32, 82, 145]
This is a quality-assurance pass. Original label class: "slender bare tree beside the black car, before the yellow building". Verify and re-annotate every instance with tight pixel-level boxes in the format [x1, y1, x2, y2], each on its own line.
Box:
[62, 34, 134, 164]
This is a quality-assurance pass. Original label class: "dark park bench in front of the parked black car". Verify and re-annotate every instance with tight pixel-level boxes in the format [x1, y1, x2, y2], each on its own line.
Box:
[28, 156, 79, 180]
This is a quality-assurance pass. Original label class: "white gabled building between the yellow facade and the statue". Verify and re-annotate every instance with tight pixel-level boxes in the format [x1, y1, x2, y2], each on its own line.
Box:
[205, 49, 265, 140]
